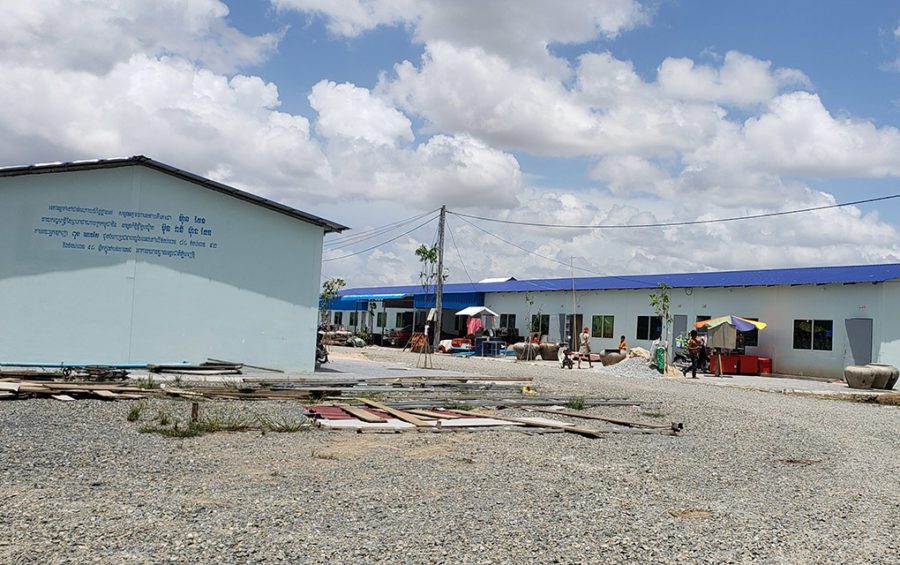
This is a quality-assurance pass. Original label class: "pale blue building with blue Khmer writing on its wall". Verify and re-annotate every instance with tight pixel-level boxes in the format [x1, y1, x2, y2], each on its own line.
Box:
[0, 156, 346, 371]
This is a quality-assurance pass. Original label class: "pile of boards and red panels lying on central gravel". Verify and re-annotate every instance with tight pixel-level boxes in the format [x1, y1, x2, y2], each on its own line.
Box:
[306, 398, 684, 438]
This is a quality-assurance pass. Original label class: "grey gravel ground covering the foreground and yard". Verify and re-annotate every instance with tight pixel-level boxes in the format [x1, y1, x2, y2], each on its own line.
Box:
[0, 349, 900, 564]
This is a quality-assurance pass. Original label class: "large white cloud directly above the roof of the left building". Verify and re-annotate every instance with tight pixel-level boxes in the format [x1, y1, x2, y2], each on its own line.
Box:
[0, 55, 329, 195]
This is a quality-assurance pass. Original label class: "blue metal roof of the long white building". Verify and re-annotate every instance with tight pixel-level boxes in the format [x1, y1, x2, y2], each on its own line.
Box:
[341, 263, 900, 295]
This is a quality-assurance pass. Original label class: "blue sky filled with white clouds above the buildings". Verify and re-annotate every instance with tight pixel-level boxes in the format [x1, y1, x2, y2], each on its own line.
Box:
[0, 0, 900, 286]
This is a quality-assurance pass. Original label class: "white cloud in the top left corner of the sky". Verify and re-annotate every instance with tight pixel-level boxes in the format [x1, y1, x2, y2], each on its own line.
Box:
[0, 0, 281, 74]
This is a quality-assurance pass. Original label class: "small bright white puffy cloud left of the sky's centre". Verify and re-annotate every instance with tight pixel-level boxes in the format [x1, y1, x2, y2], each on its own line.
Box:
[309, 81, 413, 145]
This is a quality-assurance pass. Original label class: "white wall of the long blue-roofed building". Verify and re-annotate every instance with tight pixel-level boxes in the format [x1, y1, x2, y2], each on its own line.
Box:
[485, 282, 900, 379]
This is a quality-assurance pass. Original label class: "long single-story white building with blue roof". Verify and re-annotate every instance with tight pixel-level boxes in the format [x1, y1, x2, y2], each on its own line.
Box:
[332, 264, 900, 378]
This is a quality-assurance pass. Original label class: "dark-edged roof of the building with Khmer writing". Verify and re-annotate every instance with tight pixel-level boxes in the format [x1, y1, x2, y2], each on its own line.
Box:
[0, 155, 350, 233]
